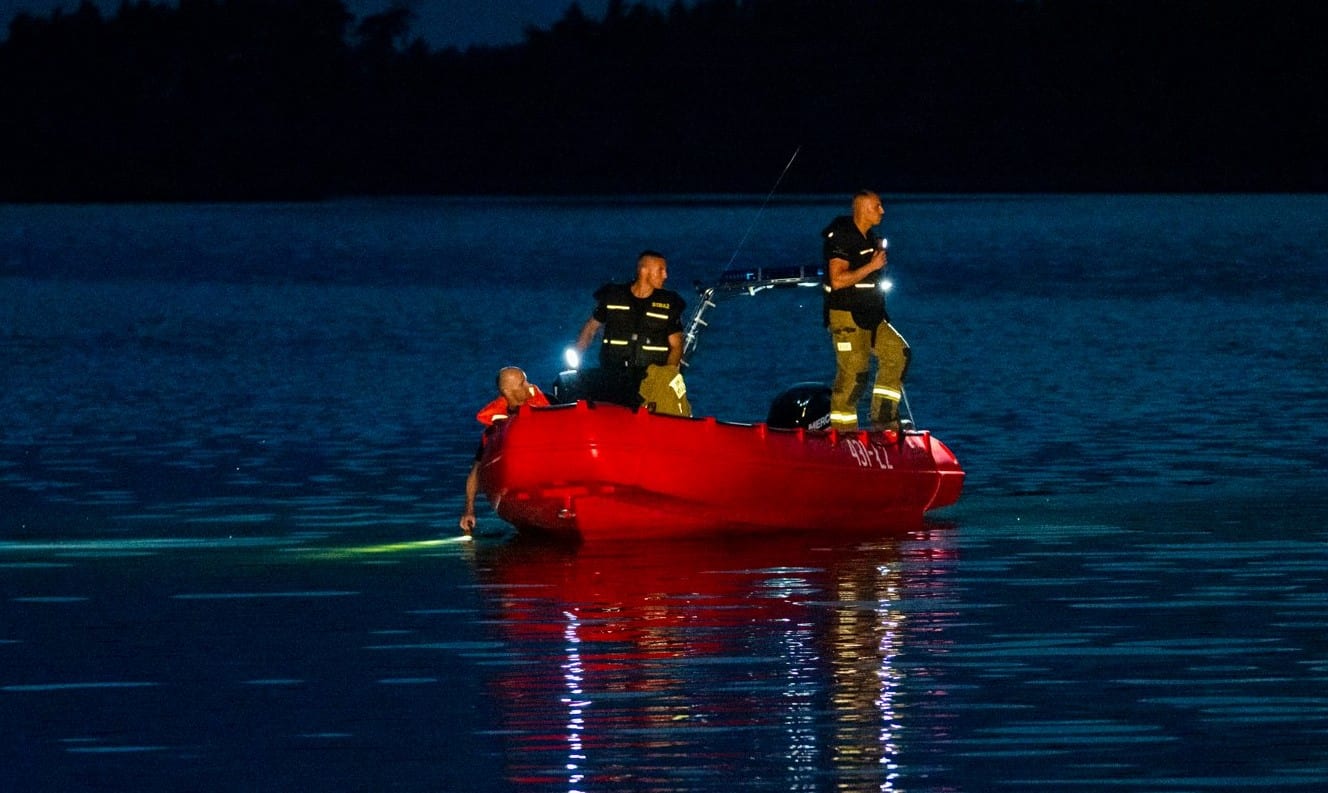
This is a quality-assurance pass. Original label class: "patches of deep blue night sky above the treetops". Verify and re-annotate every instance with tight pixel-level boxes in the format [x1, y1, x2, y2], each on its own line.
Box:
[0, 0, 667, 49]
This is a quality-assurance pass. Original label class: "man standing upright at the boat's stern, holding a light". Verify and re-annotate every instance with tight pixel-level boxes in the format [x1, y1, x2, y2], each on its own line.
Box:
[821, 190, 908, 430]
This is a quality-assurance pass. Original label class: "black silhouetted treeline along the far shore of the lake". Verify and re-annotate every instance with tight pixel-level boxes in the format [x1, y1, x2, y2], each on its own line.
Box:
[0, 0, 1328, 201]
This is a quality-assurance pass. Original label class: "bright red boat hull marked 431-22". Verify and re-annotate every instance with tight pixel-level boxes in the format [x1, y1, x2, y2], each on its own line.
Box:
[479, 401, 964, 539]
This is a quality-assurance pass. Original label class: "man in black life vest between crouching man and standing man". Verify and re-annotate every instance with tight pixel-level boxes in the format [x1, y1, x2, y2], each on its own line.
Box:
[576, 251, 692, 416]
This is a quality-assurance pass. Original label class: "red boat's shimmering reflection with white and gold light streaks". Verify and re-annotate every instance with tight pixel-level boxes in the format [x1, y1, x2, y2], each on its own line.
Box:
[475, 530, 952, 792]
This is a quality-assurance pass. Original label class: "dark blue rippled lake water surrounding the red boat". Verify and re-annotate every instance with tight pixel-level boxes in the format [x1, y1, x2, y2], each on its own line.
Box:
[0, 197, 1328, 792]
